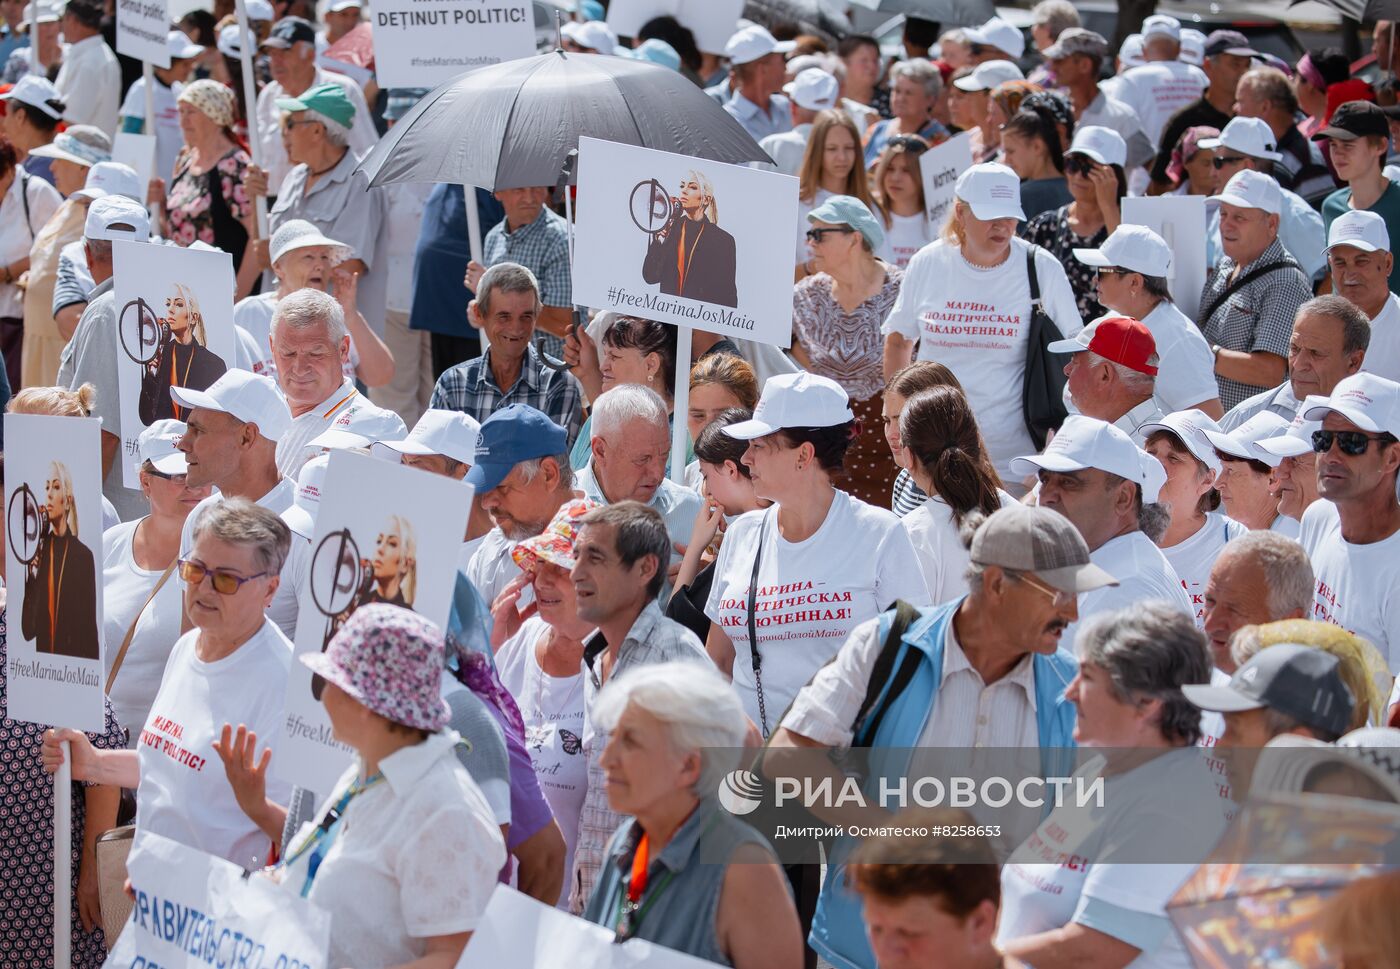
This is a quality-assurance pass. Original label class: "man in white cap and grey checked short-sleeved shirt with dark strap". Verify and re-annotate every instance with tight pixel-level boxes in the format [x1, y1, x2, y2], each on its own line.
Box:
[1198, 171, 1312, 416]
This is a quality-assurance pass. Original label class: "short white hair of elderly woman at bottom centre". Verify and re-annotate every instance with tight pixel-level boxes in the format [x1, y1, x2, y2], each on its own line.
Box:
[592, 662, 746, 798]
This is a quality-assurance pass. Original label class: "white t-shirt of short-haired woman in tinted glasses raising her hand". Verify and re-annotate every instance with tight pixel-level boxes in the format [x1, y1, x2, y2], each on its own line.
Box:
[136, 619, 291, 868]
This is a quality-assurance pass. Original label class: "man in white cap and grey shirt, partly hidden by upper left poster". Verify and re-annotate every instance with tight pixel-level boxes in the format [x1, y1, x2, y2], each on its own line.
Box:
[59, 196, 150, 518]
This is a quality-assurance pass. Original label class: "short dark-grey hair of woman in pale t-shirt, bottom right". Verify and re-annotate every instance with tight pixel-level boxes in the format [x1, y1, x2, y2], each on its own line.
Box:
[1074, 599, 1211, 746]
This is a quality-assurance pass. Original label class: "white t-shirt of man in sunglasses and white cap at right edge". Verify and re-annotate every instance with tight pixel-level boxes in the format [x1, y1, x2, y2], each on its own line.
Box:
[1298, 499, 1400, 674]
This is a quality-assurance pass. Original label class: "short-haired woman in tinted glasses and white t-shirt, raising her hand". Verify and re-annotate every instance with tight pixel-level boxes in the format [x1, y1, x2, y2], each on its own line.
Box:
[43, 499, 291, 868]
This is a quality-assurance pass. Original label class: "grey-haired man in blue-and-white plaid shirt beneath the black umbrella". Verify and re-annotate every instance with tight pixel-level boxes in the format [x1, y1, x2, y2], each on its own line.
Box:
[428, 262, 584, 452]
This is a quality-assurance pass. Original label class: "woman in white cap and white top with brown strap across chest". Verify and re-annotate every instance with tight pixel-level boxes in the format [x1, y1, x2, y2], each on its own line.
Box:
[102, 420, 211, 746]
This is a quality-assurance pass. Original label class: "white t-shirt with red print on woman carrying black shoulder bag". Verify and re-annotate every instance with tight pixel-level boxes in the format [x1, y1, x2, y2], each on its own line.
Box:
[881, 239, 1084, 482]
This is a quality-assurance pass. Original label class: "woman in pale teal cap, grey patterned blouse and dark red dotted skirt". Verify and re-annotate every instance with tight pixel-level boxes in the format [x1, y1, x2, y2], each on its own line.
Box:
[792, 195, 904, 504]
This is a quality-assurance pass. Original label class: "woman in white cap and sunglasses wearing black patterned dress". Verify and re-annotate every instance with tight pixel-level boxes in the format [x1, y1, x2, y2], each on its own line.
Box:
[1021, 125, 1128, 319]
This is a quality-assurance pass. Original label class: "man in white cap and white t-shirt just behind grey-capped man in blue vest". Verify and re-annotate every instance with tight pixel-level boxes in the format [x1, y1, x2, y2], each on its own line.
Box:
[1011, 414, 1196, 648]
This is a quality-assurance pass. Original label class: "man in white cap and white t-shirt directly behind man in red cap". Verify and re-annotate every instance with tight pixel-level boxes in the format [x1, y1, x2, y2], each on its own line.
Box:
[1074, 223, 1224, 420]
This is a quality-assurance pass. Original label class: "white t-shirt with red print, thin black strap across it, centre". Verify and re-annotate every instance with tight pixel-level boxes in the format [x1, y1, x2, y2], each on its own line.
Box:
[704, 490, 928, 730]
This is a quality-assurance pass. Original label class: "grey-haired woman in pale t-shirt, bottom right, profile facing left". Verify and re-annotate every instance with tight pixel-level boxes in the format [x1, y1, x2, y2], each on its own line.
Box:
[997, 601, 1226, 966]
